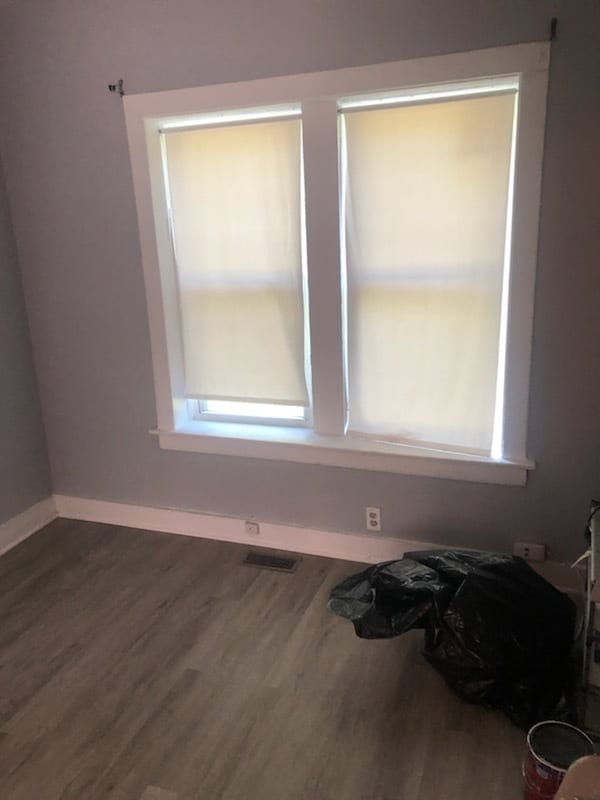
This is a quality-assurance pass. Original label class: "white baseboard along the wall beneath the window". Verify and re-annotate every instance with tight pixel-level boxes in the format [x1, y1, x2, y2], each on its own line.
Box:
[54, 495, 441, 563]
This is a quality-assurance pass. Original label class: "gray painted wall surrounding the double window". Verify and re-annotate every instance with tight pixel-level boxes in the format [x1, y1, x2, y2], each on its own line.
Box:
[0, 0, 600, 558]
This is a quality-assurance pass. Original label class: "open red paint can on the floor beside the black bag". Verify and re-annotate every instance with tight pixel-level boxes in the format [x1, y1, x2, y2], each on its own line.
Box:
[523, 720, 594, 800]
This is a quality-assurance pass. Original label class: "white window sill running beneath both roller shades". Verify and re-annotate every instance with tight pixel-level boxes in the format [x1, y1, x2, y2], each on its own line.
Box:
[151, 421, 535, 486]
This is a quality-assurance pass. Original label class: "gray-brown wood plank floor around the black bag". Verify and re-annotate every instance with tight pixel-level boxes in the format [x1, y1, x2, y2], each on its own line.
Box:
[0, 520, 524, 800]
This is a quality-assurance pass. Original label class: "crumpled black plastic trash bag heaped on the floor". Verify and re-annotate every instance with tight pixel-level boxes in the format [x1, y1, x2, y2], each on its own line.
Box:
[329, 551, 575, 728]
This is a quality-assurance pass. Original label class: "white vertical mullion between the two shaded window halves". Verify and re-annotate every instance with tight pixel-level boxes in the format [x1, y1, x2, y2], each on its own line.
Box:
[302, 99, 345, 436]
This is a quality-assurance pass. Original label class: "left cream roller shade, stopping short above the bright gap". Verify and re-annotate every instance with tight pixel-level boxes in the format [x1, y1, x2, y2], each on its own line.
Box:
[164, 119, 308, 406]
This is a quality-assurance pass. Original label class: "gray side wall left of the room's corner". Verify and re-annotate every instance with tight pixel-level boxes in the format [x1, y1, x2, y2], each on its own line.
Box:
[0, 152, 52, 524]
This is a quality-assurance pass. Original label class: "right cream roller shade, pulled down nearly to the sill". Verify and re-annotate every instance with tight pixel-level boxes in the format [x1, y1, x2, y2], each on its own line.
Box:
[343, 94, 515, 453]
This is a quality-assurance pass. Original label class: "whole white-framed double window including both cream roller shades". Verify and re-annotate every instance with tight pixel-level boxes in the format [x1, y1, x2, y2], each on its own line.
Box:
[125, 44, 548, 483]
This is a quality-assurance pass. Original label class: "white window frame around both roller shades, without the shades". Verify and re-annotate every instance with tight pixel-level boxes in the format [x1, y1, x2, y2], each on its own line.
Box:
[124, 42, 550, 485]
